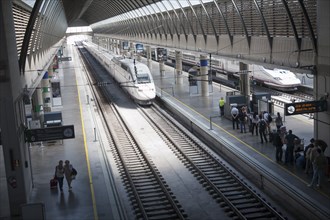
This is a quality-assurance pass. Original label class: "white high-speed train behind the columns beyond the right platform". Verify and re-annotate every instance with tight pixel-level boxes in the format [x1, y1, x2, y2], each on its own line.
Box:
[168, 51, 301, 91]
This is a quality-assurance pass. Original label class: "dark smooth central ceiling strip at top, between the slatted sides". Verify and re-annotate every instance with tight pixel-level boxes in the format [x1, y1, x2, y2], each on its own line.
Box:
[63, 0, 160, 27]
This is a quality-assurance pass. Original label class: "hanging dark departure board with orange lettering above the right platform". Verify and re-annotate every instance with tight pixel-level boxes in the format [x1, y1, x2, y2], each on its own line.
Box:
[284, 100, 328, 116]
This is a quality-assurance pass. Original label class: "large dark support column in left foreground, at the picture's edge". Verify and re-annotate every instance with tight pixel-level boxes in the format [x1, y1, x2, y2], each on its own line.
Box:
[0, 0, 32, 219]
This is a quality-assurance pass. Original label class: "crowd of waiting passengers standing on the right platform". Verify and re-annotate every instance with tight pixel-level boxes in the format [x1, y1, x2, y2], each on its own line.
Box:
[231, 106, 330, 187]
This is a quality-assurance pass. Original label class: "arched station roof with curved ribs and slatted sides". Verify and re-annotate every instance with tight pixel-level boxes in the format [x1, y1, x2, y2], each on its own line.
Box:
[14, 0, 317, 71]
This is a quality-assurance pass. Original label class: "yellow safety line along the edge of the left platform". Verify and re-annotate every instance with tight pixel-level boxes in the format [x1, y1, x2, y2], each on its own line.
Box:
[76, 71, 98, 220]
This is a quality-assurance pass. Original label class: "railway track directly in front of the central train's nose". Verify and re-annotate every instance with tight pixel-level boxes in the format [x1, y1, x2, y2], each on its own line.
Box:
[140, 107, 286, 219]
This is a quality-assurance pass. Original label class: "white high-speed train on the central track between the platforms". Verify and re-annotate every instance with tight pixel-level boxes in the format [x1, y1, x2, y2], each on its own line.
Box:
[83, 41, 156, 105]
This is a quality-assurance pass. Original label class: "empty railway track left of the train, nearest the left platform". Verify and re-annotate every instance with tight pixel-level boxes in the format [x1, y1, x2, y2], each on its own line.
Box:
[78, 45, 187, 219]
